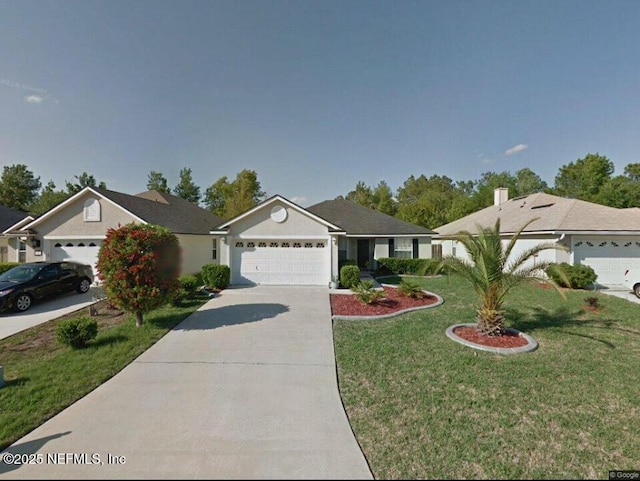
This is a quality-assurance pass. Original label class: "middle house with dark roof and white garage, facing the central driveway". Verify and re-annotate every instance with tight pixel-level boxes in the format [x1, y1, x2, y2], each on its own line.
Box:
[211, 195, 434, 285]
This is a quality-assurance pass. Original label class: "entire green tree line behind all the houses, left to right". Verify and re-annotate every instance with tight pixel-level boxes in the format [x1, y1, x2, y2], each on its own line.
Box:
[0, 153, 640, 229]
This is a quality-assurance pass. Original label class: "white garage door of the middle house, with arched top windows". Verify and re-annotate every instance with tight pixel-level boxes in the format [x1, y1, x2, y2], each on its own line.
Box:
[231, 239, 331, 285]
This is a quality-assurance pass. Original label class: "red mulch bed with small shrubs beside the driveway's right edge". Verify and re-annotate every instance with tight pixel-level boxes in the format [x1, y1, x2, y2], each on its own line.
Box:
[331, 287, 438, 316]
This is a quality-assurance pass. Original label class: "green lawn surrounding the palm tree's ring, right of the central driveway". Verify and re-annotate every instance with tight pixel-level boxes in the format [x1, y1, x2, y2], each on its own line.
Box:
[334, 277, 640, 479]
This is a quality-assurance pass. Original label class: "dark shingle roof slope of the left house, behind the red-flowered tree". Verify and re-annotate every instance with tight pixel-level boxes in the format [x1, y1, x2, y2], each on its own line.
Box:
[94, 189, 223, 234]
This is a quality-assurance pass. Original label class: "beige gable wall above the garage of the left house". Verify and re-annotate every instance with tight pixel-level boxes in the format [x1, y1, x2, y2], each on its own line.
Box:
[34, 192, 138, 238]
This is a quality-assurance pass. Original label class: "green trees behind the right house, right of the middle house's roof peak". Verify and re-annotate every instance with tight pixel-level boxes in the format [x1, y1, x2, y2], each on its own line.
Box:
[338, 153, 640, 229]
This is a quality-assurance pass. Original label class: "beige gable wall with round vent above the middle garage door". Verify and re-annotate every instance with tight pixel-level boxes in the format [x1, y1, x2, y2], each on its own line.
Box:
[229, 201, 329, 239]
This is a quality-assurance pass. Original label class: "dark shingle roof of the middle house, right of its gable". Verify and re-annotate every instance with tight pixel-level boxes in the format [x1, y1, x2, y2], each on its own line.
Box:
[307, 199, 435, 236]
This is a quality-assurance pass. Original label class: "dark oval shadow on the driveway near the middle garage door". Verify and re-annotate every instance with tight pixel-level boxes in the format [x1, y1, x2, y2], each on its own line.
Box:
[174, 303, 289, 331]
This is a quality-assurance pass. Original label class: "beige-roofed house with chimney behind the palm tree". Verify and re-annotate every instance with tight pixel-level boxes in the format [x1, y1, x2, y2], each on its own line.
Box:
[434, 188, 640, 285]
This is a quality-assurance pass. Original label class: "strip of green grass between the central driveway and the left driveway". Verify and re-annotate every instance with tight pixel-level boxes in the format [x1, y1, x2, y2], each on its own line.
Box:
[0, 298, 206, 450]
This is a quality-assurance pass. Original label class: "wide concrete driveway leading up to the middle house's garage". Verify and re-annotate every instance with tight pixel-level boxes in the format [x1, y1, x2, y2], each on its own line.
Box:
[0, 286, 371, 479]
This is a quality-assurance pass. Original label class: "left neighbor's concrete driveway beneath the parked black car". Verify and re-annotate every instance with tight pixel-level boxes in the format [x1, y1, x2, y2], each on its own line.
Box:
[0, 287, 94, 339]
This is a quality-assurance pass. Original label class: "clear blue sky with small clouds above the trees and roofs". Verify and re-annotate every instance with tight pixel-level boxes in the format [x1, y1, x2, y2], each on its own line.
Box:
[0, 0, 640, 205]
